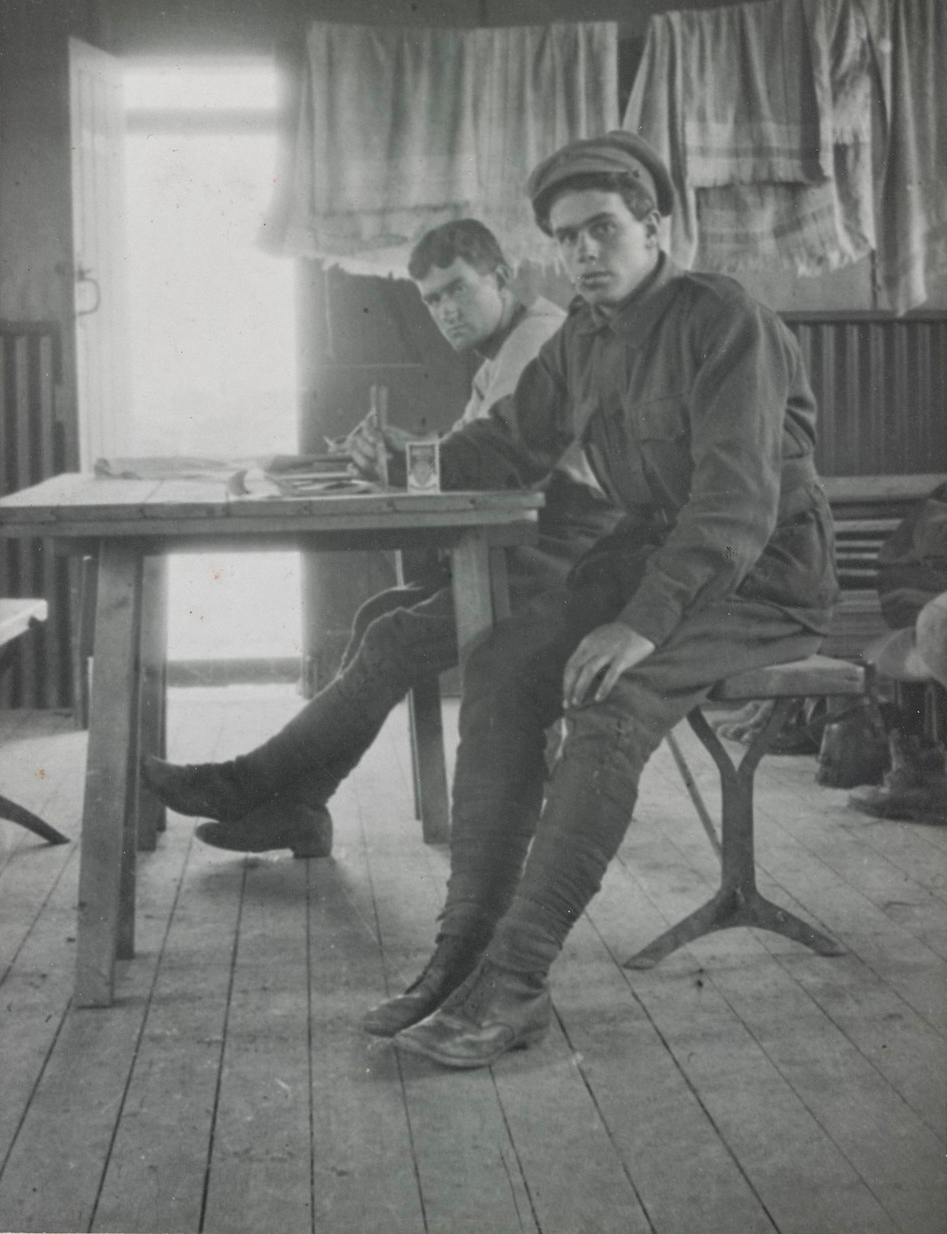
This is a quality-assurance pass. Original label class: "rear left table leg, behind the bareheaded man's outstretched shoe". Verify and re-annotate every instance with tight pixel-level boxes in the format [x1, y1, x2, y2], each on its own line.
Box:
[137, 557, 168, 853]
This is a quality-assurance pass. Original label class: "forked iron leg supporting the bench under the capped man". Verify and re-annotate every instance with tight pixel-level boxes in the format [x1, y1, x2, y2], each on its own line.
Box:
[625, 698, 845, 969]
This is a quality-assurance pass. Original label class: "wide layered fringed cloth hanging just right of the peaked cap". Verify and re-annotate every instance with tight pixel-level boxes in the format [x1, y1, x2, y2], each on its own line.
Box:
[624, 0, 874, 274]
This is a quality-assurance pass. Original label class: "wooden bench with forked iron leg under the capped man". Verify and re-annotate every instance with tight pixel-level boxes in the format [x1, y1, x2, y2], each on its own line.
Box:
[625, 655, 868, 969]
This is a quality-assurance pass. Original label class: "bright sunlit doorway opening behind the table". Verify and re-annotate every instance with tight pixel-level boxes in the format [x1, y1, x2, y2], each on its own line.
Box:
[122, 58, 301, 663]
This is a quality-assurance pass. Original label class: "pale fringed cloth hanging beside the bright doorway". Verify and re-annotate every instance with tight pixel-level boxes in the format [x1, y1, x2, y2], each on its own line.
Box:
[263, 22, 617, 274]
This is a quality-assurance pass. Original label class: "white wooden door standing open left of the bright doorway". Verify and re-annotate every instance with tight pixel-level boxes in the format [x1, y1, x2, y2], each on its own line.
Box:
[69, 38, 131, 469]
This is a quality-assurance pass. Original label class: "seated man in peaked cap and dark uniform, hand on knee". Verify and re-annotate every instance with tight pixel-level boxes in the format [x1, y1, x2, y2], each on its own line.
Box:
[364, 132, 837, 1067]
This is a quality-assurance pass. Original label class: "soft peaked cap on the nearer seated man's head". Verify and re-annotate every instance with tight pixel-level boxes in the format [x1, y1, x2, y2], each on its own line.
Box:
[526, 130, 674, 232]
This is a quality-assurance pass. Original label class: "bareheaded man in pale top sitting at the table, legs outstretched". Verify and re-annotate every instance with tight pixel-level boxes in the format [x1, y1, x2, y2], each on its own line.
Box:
[142, 218, 617, 856]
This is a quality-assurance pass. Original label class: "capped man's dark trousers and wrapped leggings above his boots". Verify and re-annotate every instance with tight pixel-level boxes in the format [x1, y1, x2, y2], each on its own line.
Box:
[441, 581, 821, 971]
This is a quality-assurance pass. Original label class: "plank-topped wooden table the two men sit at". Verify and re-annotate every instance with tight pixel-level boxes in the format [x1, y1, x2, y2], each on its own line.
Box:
[0, 474, 542, 1007]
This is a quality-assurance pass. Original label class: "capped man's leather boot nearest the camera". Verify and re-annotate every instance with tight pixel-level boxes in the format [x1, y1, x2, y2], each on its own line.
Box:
[394, 960, 552, 1067]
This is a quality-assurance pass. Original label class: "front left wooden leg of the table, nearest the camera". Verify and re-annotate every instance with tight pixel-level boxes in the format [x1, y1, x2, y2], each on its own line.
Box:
[75, 542, 142, 1007]
